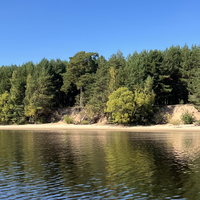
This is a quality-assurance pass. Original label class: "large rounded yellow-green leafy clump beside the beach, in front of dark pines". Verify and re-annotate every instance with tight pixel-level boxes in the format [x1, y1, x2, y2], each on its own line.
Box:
[105, 77, 155, 124]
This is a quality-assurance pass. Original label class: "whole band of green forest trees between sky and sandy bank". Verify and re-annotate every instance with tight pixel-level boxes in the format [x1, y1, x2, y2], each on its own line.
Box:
[0, 45, 200, 124]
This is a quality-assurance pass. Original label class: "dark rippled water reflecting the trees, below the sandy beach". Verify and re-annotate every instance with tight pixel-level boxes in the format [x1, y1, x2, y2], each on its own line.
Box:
[0, 131, 200, 200]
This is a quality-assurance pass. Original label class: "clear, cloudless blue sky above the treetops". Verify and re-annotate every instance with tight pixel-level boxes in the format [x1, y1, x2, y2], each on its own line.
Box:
[0, 0, 200, 66]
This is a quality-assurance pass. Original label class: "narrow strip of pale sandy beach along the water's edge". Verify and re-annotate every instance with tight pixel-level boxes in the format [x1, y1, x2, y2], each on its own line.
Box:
[0, 123, 200, 132]
